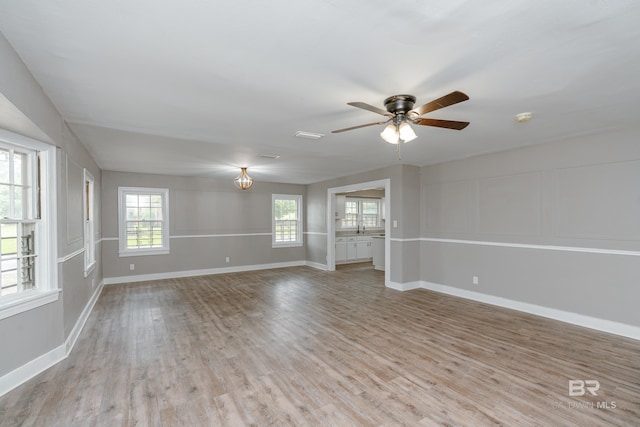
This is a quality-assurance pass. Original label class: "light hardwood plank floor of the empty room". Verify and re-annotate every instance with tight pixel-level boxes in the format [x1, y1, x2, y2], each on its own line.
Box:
[0, 265, 640, 426]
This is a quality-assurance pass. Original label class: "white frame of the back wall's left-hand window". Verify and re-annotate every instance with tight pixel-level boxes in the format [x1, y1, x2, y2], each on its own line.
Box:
[118, 187, 170, 257]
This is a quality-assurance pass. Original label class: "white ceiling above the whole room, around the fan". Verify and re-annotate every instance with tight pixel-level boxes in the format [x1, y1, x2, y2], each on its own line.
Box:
[0, 0, 640, 184]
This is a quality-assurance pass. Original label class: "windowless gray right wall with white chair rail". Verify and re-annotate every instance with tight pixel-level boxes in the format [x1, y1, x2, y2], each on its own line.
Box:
[419, 132, 640, 325]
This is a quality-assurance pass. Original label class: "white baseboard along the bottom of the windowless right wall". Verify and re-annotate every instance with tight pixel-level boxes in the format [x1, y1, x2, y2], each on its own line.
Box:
[416, 281, 640, 340]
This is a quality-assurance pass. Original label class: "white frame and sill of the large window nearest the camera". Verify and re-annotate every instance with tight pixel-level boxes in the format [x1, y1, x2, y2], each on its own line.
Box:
[0, 129, 61, 319]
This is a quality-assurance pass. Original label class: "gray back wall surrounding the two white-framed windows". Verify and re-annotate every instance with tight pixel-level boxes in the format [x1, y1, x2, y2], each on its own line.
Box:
[102, 171, 307, 281]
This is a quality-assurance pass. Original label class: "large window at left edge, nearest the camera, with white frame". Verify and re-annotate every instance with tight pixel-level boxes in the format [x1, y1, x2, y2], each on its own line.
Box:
[0, 130, 58, 319]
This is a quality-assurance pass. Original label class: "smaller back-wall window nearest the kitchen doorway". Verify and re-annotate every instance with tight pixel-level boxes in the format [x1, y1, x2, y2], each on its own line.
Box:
[271, 194, 302, 247]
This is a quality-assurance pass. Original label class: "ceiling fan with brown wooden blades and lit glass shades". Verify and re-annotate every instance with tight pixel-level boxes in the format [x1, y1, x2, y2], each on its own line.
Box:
[331, 91, 469, 144]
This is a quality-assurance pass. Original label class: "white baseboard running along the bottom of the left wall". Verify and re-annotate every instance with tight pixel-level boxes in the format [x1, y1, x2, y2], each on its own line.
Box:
[0, 282, 103, 396]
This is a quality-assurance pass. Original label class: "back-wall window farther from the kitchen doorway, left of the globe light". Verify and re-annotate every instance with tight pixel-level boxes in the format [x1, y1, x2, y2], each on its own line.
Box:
[118, 187, 169, 256]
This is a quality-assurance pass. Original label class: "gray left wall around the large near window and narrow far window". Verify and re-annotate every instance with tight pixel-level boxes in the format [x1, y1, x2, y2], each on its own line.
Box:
[0, 34, 102, 376]
